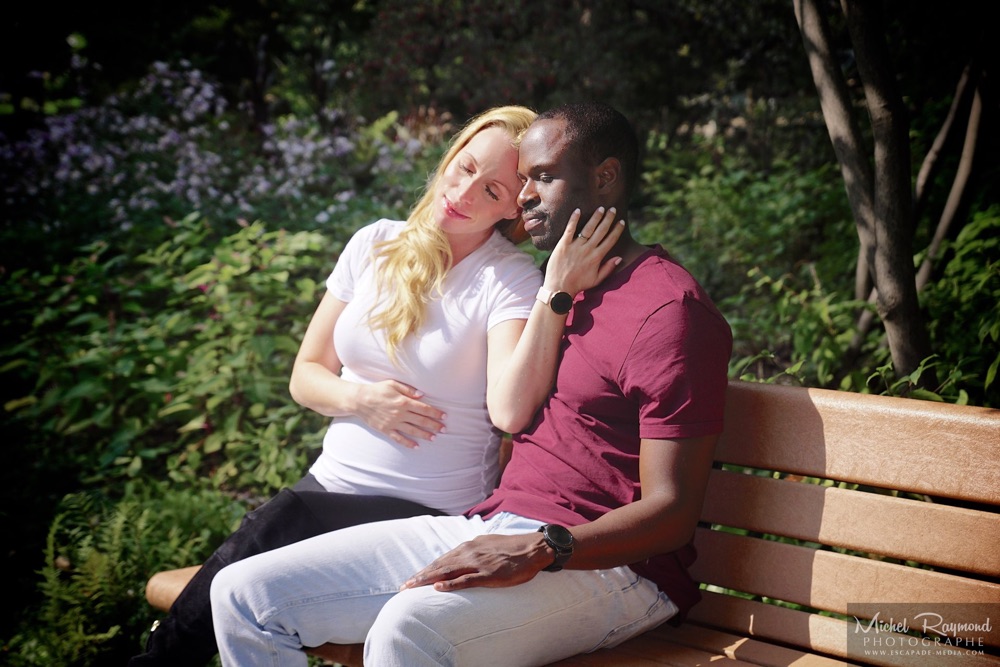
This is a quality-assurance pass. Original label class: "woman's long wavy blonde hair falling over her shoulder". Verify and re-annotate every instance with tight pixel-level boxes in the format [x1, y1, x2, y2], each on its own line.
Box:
[369, 106, 536, 363]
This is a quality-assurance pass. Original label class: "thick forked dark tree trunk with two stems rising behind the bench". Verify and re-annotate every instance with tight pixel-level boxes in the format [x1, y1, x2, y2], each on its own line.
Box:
[793, 0, 934, 383]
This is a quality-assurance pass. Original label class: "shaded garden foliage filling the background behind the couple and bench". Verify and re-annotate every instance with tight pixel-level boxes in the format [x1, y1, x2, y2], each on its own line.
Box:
[0, 0, 1000, 665]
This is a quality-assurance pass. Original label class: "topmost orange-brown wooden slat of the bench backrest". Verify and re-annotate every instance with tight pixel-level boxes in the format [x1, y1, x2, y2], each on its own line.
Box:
[716, 381, 1000, 505]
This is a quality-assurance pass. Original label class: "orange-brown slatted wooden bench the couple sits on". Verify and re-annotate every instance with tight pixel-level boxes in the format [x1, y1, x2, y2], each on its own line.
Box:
[146, 381, 1000, 667]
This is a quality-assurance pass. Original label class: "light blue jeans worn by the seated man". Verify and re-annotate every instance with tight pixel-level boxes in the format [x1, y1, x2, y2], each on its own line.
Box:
[212, 514, 677, 667]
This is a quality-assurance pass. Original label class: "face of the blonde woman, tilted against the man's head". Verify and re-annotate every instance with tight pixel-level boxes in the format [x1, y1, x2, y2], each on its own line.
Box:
[434, 127, 521, 236]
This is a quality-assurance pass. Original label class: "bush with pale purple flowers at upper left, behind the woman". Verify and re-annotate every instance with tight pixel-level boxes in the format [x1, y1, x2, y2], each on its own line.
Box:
[0, 61, 439, 270]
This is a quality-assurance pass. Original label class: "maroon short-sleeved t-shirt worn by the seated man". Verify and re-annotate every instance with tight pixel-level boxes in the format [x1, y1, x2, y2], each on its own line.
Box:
[468, 246, 732, 614]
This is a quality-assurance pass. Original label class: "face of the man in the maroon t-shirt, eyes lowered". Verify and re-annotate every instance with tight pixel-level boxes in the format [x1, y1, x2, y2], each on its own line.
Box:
[517, 119, 597, 250]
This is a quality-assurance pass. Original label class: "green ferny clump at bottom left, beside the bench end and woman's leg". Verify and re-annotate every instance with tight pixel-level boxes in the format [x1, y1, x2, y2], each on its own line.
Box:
[5, 480, 244, 667]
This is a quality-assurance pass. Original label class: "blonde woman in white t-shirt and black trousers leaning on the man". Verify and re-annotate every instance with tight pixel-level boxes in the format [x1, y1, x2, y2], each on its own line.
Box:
[129, 106, 619, 667]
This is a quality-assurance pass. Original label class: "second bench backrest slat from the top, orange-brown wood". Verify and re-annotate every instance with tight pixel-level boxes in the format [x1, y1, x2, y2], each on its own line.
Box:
[702, 470, 1000, 576]
